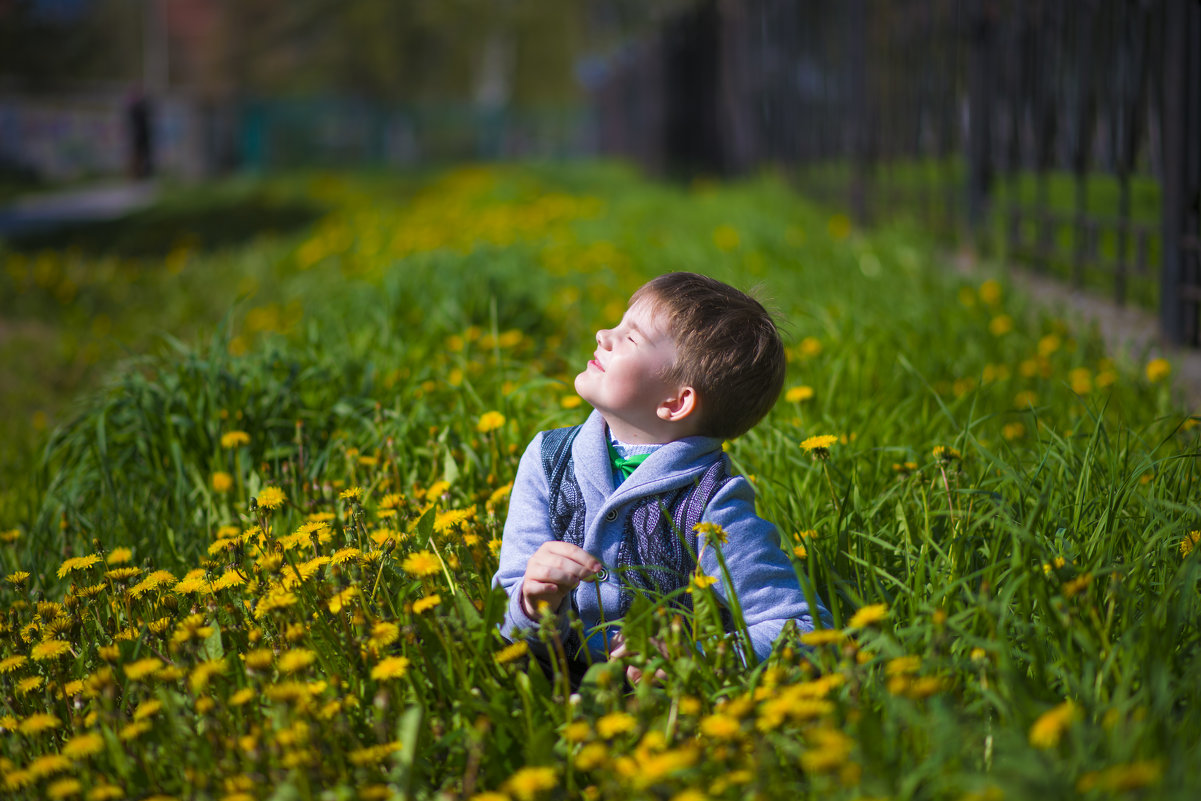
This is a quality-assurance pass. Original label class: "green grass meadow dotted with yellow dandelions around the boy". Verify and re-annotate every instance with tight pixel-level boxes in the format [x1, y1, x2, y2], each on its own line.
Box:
[0, 166, 1201, 801]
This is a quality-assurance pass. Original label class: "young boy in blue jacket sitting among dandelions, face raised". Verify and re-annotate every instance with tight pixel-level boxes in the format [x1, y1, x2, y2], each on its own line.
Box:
[492, 273, 825, 666]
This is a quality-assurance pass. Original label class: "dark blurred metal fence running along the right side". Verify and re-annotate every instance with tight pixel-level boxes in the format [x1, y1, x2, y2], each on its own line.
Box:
[596, 0, 1201, 346]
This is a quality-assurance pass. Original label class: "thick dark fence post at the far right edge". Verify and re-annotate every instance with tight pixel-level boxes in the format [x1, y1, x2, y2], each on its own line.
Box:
[1159, 0, 1201, 345]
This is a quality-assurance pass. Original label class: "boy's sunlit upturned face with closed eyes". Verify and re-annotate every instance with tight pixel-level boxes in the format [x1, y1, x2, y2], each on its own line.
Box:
[575, 300, 679, 442]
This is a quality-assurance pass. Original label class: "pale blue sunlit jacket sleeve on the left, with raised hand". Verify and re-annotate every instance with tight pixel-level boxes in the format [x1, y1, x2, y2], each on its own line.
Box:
[492, 434, 568, 640]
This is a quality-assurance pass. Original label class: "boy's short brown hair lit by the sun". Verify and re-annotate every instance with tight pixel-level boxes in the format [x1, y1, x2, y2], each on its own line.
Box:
[629, 273, 785, 440]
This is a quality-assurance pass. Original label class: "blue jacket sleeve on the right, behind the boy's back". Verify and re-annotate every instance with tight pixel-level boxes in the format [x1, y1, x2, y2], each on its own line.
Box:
[700, 476, 829, 660]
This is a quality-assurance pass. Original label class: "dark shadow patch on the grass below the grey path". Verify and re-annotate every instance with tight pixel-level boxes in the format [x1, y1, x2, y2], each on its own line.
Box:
[7, 192, 324, 258]
